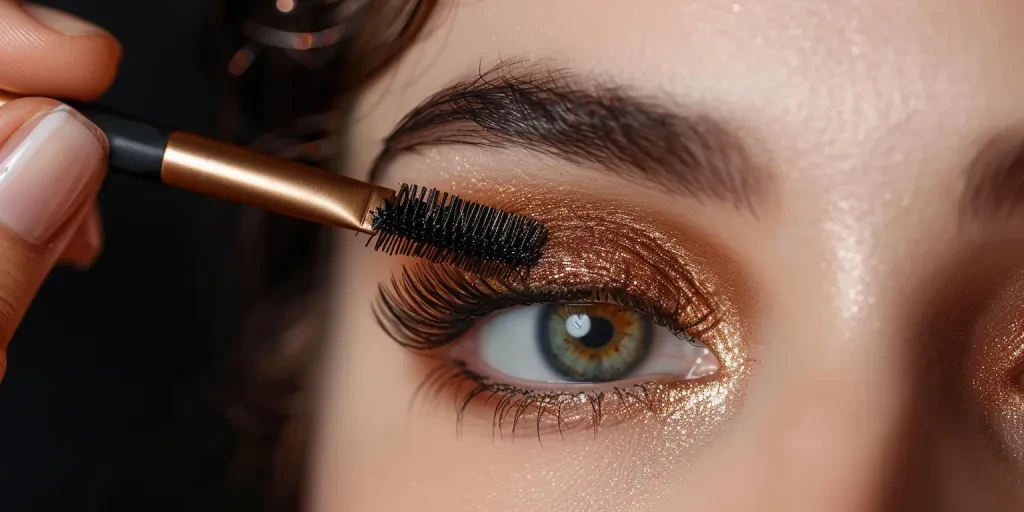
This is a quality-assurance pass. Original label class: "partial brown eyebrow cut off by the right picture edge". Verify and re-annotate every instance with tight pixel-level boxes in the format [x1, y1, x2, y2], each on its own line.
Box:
[961, 131, 1024, 219]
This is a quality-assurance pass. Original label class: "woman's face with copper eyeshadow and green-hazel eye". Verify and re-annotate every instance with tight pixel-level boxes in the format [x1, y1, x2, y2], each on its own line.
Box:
[311, 0, 1024, 512]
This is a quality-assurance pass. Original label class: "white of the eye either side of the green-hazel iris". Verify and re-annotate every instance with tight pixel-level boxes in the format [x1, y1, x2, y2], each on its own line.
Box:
[467, 305, 721, 384]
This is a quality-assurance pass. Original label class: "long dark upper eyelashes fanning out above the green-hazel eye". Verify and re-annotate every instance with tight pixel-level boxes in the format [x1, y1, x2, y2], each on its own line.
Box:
[373, 264, 717, 350]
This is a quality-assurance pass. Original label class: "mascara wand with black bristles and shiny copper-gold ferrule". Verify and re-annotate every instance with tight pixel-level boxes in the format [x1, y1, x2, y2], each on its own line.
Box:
[0, 91, 547, 269]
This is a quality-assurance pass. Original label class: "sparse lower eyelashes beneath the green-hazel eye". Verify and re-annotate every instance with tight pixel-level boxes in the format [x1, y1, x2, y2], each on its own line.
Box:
[410, 360, 660, 441]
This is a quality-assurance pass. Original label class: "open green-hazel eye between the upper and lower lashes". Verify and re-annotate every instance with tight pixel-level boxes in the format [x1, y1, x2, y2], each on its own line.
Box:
[455, 303, 720, 385]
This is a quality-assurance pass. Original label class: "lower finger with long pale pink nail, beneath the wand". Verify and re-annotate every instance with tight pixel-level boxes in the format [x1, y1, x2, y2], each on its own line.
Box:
[0, 98, 108, 379]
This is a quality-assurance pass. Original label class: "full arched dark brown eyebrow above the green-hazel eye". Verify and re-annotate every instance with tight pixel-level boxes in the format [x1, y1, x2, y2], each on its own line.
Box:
[372, 61, 771, 213]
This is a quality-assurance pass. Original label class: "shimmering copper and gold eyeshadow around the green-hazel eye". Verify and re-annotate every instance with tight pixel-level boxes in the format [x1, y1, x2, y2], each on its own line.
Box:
[376, 189, 753, 440]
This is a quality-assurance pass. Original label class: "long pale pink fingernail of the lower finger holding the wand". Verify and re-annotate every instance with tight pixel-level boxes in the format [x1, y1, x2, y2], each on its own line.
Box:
[0, 106, 106, 243]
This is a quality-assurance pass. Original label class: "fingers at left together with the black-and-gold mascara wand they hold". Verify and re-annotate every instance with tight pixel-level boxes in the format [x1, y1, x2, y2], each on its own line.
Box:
[0, 4, 547, 385]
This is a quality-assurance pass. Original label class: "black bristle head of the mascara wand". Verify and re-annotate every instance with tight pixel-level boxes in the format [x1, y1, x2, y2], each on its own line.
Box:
[368, 184, 548, 268]
